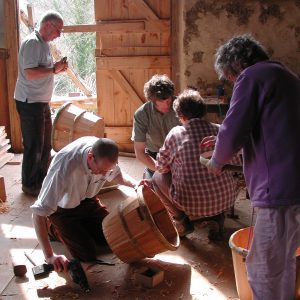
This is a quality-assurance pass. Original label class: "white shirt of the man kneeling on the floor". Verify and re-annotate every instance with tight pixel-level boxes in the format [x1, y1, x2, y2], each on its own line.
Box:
[31, 137, 121, 216]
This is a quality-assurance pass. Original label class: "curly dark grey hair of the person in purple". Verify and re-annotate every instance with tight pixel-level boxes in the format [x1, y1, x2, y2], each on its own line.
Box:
[215, 34, 270, 79]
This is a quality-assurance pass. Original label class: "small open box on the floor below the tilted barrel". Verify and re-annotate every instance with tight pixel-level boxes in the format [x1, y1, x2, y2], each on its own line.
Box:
[135, 267, 164, 288]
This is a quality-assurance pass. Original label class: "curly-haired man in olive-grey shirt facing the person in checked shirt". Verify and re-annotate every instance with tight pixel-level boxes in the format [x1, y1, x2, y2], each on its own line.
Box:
[132, 74, 180, 179]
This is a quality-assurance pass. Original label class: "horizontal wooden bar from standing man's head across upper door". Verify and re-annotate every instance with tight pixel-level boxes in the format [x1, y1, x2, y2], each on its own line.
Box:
[63, 20, 170, 34]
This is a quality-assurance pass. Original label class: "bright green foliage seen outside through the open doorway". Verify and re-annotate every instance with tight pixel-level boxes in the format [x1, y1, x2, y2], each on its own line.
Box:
[19, 0, 96, 96]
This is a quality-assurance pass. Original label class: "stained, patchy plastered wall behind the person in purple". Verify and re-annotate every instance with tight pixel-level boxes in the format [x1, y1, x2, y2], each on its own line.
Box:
[180, 0, 300, 95]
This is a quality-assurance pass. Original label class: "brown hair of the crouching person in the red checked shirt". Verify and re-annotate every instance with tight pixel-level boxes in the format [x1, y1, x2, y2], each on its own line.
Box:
[173, 88, 206, 120]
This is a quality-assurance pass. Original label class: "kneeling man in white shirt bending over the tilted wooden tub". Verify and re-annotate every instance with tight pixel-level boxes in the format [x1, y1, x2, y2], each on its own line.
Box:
[31, 137, 137, 272]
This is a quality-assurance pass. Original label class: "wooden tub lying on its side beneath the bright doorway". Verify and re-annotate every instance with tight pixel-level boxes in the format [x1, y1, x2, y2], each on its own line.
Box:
[51, 102, 104, 152]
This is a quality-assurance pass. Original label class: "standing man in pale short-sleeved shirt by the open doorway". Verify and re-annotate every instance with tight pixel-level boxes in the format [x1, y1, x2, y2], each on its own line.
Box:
[15, 11, 68, 196]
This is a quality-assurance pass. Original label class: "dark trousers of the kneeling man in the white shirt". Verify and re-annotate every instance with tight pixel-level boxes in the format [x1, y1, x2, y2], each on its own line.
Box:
[48, 198, 108, 261]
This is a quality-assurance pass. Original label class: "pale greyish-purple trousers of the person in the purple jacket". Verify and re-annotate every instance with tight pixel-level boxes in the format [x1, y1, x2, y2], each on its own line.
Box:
[246, 205, 300, 300]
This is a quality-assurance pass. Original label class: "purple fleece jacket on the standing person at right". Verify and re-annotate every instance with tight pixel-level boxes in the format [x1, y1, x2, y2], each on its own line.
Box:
[213, 61, 300, 207]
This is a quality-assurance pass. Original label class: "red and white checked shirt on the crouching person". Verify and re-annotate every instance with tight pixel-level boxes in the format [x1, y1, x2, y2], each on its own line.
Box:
[156, 119, 238, 217]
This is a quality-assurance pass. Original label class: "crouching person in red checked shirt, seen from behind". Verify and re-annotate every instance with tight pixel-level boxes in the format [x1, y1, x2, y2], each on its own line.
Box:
[152, 89, 239, 236]
